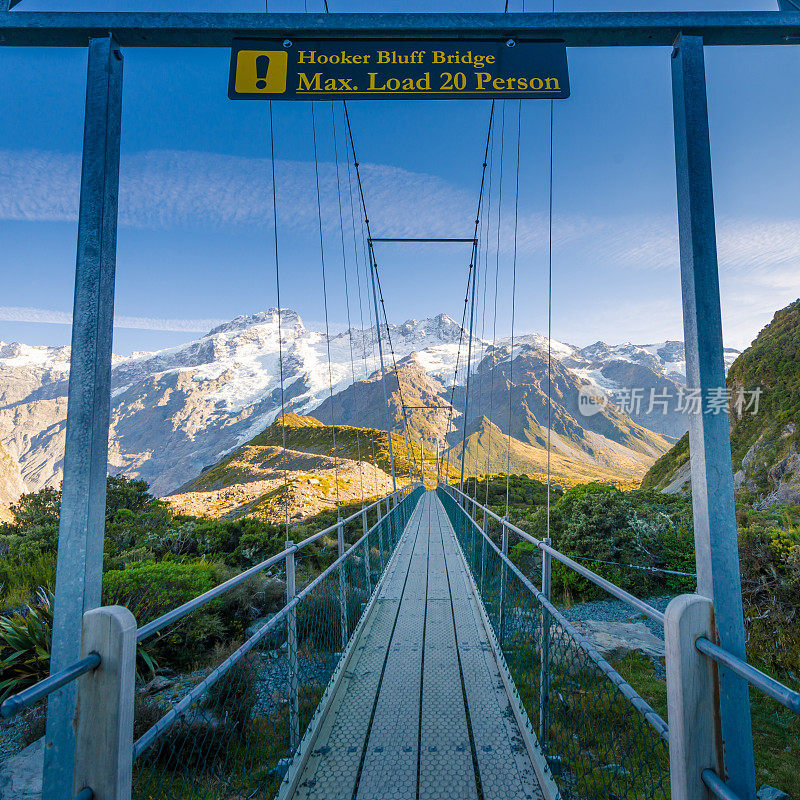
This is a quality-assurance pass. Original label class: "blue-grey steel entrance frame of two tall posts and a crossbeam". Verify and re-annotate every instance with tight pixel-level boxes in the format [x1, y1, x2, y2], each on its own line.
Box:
[0, 9, 800, 800]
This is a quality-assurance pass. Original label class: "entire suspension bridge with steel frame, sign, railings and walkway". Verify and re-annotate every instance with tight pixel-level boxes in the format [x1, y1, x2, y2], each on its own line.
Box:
[0, 0, 800, 800]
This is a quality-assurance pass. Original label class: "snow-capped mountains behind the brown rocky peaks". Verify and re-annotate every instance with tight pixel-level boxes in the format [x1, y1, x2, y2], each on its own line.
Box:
[0, 308, 736, 504]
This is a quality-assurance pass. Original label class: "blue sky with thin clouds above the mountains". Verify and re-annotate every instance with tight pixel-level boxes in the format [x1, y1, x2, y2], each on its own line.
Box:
[0, 0, 800, 353]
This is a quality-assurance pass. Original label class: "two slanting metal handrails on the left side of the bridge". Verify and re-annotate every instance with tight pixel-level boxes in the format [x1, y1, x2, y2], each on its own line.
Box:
[133, 484, 416, 760]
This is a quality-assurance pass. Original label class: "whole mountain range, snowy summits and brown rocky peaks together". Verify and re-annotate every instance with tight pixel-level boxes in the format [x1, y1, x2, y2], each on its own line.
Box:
[0, 309, 736, 503]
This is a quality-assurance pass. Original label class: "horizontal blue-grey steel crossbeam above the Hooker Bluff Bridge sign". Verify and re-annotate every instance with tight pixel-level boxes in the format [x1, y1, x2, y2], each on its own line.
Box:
[0, 11, 800, 47]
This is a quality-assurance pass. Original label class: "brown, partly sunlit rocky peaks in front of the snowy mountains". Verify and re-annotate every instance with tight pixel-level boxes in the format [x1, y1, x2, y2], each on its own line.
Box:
[311, 342, 670, 484]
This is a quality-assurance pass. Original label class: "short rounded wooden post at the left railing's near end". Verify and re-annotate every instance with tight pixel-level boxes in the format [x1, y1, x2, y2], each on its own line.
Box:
[72, 606, 136, 800]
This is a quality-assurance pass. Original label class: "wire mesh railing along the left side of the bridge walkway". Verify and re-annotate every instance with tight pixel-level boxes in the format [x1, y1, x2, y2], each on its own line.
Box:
[132, 487, 423, 800]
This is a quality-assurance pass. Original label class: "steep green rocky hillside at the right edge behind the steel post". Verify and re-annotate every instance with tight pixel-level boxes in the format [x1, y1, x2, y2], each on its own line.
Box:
[642, 300, 800, 508]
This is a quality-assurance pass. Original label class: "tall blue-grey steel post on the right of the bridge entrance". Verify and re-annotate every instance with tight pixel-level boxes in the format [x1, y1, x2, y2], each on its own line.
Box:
[672, 35, 756, 800]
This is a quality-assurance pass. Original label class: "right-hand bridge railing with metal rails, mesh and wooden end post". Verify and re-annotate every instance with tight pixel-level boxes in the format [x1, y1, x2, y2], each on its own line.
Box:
[439, 484, 800, 800]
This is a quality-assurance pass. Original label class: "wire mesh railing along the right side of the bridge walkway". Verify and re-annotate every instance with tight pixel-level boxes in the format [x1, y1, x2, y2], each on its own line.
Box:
[439, 487, 669, 800]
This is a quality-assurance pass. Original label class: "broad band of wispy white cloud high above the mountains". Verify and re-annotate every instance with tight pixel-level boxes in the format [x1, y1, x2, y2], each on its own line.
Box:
[6, 150, 800, 271]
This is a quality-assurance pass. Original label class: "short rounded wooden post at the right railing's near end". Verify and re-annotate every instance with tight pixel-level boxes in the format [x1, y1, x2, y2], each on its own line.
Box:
[664, 594, 722, 800]
